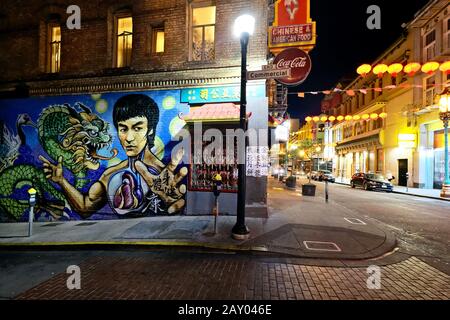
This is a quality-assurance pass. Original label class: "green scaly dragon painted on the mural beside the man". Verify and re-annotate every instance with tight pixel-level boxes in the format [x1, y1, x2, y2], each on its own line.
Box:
[0, 103, 118, 221]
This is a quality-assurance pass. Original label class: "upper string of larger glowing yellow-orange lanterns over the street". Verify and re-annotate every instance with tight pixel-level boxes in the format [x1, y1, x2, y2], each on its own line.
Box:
[356, 61, 450, 78]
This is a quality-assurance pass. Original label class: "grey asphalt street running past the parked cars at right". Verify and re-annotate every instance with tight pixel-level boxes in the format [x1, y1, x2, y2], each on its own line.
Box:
[300, 179, 450, 274]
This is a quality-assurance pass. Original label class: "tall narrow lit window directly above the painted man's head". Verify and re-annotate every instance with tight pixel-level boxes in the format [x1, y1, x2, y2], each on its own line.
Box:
[116, 17, 133, 68]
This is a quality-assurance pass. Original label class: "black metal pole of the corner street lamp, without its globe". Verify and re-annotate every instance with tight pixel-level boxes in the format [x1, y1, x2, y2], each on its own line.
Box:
[231, 32, 250, 240]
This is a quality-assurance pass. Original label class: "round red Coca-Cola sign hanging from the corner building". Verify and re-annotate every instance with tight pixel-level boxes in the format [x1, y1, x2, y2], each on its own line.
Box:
[273, 48, 312, 86]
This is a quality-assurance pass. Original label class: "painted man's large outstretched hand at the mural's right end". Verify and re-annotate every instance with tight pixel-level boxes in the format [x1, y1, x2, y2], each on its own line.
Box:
[135, 149, 188, 214]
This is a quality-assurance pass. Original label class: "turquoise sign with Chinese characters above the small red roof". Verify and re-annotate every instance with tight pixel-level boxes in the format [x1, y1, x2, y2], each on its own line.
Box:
[181, 86, 266, 104]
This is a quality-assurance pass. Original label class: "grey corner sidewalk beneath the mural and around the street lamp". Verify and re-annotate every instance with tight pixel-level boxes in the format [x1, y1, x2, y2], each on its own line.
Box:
[0, 179, 396, 260]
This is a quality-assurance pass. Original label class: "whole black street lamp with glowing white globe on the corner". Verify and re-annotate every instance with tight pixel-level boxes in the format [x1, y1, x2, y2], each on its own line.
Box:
[231, 14, 255, 240]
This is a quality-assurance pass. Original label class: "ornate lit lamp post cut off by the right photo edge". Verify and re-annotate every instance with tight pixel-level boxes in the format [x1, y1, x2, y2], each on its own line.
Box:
[438, 87, 450, 198]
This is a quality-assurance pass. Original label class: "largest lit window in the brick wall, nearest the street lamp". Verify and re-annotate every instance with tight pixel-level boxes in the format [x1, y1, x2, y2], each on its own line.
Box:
[191, 6, 216, 61]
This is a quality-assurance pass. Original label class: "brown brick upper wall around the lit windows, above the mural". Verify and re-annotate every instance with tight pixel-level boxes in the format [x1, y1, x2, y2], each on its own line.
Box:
[0, 0, 267, 82]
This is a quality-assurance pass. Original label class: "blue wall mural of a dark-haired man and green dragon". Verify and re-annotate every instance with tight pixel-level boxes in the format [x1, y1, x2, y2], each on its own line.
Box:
[0, 90, 189, 222]
